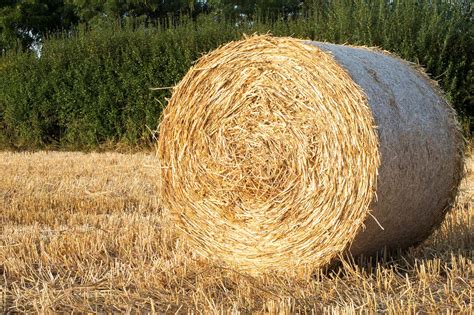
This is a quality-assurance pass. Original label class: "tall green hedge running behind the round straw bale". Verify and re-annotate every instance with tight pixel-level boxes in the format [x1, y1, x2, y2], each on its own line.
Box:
[0, 0, 474, 149]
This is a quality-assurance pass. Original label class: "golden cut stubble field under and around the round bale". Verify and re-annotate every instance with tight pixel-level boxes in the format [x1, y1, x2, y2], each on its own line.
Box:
[0, 152, 474, 314]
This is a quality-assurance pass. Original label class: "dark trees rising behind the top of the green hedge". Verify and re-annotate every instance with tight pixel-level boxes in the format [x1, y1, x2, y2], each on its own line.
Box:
[0, 0, 309, 52]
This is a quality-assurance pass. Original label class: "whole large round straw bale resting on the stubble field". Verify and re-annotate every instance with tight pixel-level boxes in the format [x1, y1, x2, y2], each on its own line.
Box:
[158, 36, 462, 273]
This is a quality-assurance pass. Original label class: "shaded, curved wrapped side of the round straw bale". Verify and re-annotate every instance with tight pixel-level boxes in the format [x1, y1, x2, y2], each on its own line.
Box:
[312, 42, 463, 255]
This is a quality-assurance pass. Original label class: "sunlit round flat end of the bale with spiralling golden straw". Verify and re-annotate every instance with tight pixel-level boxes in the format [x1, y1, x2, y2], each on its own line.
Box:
[157, 36, 379, 275]
